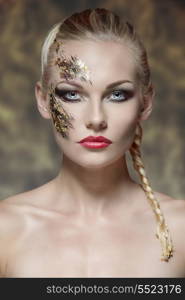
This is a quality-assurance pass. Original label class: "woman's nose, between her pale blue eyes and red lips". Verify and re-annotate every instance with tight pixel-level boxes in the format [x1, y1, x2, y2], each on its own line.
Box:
[86, 101, 107, 131]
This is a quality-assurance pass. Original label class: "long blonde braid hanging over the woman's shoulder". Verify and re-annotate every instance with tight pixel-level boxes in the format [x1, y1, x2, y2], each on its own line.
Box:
[129, 123, 173, 261]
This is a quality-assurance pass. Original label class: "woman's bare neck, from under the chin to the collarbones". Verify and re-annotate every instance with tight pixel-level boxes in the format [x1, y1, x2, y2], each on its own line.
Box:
[55, 156, 136, 214]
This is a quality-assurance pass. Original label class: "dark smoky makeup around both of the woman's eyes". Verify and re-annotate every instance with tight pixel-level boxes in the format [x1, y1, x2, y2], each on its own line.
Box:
[55, 88, 134, 103]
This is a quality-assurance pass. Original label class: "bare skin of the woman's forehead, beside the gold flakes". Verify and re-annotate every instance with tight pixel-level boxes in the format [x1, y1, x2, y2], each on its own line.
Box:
[49, 40, 136, 85]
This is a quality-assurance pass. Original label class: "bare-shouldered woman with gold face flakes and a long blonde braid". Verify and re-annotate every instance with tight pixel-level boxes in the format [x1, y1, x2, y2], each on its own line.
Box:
[0, 9, 185, 277]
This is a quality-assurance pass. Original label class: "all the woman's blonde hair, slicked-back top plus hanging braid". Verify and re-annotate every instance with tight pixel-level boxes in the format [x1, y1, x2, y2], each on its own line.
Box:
[41, 8, 173, 261]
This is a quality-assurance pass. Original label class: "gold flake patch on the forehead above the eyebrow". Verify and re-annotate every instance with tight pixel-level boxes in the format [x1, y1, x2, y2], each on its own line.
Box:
[55, 40, 92, 84]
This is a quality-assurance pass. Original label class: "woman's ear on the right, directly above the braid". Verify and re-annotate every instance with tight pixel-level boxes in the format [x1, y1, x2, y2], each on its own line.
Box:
[139, 87, 155, 121]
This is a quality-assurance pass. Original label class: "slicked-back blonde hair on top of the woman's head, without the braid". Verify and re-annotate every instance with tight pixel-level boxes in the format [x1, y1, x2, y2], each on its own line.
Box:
[41, 8, 152, 94]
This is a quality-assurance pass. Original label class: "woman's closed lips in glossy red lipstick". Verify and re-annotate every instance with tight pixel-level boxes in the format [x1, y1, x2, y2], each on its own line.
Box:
[78, 136, 112, 149]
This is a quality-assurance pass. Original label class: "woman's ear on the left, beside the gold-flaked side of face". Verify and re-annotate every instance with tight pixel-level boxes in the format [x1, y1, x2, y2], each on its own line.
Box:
[35, 81, 51, 119]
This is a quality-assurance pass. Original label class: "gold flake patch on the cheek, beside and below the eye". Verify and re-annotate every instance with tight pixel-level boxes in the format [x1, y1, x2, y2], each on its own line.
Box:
[49, 86, 73, 137]
